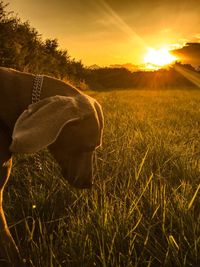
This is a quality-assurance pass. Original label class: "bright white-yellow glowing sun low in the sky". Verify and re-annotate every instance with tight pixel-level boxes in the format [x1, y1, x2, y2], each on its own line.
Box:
[144, 48, 177, 69]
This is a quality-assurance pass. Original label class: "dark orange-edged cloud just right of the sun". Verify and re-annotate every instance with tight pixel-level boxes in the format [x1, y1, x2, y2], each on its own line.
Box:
[171, 42, 200, 66]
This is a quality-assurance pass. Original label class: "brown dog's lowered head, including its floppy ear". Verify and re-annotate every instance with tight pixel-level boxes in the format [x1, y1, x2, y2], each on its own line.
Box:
[10, 94, 103, 188]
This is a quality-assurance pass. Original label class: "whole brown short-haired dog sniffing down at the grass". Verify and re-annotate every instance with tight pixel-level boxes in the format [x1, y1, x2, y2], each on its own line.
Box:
[0, 68, 103, 267]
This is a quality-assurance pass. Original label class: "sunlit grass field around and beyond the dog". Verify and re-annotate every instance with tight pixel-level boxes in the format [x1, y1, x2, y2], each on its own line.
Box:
[4, 90, 200, 267]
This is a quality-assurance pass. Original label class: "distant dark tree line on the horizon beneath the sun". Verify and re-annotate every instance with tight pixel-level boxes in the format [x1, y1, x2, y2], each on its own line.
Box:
[85, 62, 200, 91]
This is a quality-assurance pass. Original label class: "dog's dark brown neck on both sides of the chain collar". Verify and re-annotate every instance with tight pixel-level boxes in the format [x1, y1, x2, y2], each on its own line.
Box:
[0, 67, 80, 132]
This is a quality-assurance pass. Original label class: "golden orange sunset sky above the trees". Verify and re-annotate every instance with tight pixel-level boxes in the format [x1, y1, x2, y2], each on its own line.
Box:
[7, 0, 200, 66]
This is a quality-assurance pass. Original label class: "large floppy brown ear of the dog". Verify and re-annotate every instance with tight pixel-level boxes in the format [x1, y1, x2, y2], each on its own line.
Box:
[10, 96, 87, 153]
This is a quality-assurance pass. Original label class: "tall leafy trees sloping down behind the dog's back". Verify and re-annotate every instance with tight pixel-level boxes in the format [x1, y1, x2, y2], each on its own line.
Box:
[0, 0, 84, 86]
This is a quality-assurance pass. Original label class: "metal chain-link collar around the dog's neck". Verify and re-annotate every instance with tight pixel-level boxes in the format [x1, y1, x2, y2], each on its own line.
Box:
[32, 75, 44, 171]
